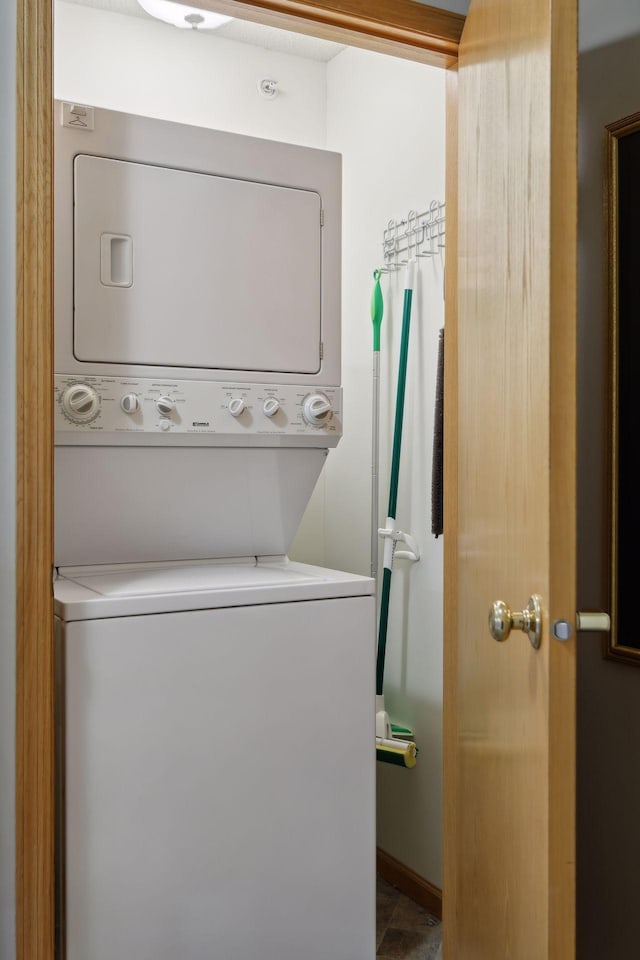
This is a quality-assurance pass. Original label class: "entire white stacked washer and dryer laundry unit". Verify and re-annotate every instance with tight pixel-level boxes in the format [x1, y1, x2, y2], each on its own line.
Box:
[55, 104, 375, 960]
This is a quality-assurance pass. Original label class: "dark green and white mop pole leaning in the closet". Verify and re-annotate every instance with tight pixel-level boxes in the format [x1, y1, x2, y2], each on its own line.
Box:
[376, 261, 415, 695]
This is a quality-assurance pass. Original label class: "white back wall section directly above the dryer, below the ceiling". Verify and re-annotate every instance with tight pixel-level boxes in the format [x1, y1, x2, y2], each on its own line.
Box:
[54, 0, 326, 147]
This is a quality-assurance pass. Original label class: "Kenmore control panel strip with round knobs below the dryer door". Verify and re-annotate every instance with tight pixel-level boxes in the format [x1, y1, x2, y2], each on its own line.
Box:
[55, 375, 342, 447]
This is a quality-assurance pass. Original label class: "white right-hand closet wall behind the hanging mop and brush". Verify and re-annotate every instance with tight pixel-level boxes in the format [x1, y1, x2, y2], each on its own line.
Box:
[324, 49, 444, 885]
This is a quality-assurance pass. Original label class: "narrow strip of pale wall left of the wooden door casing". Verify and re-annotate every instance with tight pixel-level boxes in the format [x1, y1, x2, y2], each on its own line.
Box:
[0, 3, 16, 960]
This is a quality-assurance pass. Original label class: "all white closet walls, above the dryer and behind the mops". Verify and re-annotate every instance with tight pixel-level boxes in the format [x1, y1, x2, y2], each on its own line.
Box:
[55, 0, 444, 884]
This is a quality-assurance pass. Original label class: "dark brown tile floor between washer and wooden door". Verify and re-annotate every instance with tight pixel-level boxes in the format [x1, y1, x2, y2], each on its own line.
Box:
[376, 877, 442, 960]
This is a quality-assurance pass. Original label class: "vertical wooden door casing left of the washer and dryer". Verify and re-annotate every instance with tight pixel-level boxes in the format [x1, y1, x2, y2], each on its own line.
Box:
[16, 0, 55, 960]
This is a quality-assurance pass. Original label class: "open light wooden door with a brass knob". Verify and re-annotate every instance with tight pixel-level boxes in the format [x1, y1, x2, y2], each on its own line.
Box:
[444, 0, 577, 960]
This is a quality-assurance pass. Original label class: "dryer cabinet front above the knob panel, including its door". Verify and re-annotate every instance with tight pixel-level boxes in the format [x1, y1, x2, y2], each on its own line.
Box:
[55, 103, 342, 387]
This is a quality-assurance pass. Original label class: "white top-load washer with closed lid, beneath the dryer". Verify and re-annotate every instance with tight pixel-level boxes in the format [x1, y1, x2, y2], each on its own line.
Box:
[56, 561, 375, 960]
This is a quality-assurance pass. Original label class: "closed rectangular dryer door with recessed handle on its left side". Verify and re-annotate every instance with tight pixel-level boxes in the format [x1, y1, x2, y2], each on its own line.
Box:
[74, 155, 321, 374]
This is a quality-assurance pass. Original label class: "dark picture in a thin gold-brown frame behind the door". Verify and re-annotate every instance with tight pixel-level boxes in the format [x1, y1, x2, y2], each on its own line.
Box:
[606, 111, 640, 666]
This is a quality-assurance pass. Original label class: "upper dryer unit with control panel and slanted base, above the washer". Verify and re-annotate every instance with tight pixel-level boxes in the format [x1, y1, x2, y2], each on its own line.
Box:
[55, 103, 342, 565]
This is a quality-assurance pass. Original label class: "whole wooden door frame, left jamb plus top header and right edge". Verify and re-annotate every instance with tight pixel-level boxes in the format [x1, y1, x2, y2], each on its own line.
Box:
[15, 0, 465, 960]
